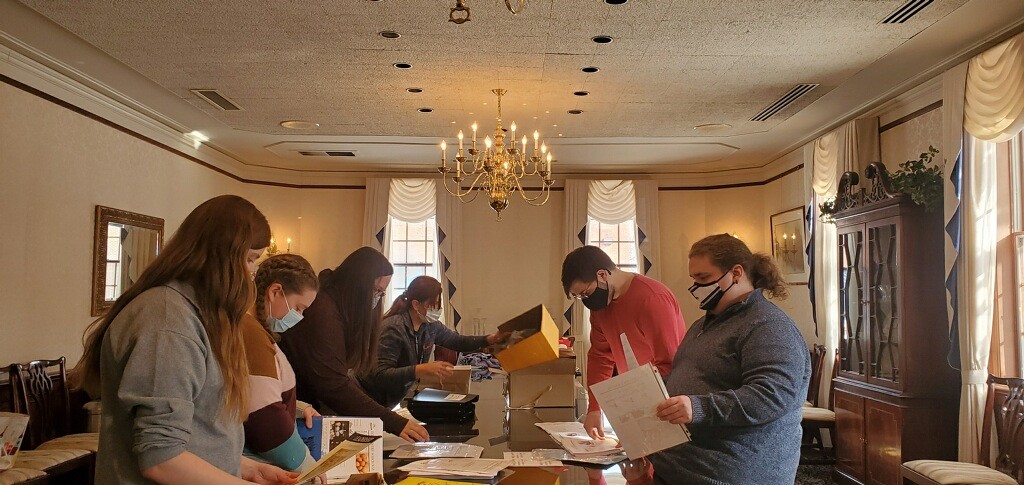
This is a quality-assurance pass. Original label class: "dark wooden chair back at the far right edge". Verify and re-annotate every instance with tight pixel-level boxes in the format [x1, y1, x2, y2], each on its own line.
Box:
[981, 376, 1024, 483]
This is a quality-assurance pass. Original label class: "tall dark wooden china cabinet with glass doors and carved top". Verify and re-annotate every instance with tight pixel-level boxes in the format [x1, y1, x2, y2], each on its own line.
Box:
[834, 164, 959, 485]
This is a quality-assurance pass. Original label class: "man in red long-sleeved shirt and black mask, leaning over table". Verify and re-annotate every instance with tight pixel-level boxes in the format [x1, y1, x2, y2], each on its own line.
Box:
[562, 246, 686, 438]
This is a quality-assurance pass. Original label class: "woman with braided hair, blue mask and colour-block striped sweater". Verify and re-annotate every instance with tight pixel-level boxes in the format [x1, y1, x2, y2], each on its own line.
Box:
[242, 254, 319, 478]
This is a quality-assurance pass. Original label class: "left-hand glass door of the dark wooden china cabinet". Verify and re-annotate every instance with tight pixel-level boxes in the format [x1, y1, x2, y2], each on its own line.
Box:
[839, 226, 867, 377]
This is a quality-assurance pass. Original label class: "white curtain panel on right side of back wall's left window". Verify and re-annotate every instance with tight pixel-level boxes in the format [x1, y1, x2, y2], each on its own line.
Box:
[434, 183, 464, 328]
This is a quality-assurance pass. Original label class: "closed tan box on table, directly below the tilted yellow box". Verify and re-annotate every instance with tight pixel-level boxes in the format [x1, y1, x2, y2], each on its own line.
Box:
[508, 357, 577, 409]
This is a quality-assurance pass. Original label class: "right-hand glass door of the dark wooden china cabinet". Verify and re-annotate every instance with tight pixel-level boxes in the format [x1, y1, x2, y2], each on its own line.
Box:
[867, 220, 902, 385]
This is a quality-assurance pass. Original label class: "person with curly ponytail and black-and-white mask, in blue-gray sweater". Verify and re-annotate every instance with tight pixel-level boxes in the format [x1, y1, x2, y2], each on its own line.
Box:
[630, 234, 811, 485]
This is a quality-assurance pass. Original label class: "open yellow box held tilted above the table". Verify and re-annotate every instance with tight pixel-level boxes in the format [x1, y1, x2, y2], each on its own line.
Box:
[495, 305, 558, 372]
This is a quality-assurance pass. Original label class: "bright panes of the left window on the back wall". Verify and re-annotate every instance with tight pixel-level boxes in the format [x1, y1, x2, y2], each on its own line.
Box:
[387, 216, 440, 302]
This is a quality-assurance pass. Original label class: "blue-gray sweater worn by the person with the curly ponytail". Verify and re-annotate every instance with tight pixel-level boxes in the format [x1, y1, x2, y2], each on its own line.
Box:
[649, 290, 811, 485]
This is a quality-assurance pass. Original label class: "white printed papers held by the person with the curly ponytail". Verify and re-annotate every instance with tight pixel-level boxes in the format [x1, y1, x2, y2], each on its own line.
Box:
[589, 363, 690, 459]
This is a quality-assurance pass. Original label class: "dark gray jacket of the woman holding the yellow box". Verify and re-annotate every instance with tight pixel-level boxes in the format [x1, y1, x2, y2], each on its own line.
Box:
[359, 312, 487, 407]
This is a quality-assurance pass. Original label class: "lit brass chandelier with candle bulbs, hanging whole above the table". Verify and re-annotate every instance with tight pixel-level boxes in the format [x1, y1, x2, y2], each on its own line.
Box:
[437, 89, 557, 222]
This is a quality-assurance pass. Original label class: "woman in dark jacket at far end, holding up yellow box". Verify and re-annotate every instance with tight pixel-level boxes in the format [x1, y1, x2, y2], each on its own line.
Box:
[359, 276, 508, 407]
